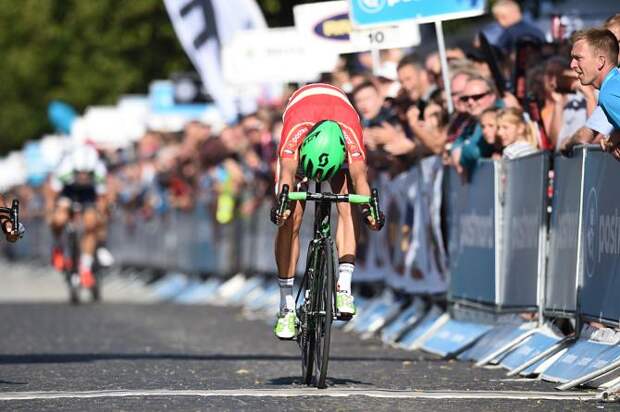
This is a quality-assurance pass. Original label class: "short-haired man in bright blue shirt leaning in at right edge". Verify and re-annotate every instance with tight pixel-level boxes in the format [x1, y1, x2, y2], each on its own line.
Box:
[571, 29, 620, 160]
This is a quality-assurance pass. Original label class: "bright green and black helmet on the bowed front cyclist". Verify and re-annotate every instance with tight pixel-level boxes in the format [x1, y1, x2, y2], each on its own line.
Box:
[299, 120, 345, 182]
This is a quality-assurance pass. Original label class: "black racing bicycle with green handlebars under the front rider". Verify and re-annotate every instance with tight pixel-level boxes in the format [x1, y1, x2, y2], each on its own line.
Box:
[278, 182, 380, 388]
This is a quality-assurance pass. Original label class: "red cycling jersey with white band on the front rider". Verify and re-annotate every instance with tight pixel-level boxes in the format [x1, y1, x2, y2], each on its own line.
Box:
[278, 83, 366, 163]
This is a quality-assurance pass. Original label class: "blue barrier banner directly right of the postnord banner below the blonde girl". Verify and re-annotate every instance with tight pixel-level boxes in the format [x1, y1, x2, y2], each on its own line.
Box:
[497, 152, 549, 308]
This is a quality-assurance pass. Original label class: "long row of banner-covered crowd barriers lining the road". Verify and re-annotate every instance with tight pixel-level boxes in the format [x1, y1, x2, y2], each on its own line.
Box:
[9, 147, 620, 325]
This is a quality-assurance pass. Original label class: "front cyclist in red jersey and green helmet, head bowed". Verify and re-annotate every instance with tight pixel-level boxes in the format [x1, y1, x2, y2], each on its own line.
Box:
[271, 83, 384, 339]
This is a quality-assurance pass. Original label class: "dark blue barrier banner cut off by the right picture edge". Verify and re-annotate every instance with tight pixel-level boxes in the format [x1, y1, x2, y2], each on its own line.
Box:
[581, 148, 620, 325]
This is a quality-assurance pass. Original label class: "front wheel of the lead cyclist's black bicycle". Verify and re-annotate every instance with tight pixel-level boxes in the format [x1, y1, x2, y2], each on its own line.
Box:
[314, 239, 335, 389]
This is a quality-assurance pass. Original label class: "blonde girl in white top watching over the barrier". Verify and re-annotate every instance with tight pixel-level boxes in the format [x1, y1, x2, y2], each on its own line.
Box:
[497, 107, 538, 159]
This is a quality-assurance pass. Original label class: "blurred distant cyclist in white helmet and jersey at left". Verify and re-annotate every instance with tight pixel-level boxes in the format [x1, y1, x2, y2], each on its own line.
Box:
[46, 144, 107, 288]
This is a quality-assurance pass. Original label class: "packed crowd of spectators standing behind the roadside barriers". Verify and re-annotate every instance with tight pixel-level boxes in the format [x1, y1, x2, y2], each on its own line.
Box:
[8, 0, 620, 272]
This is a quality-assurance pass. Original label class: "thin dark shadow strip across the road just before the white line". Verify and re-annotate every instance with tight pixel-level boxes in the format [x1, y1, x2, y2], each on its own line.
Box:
[0, 353, 441, 365]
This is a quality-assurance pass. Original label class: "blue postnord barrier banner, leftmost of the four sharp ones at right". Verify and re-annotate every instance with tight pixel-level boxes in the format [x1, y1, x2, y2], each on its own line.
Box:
[444, 161, 495, 305]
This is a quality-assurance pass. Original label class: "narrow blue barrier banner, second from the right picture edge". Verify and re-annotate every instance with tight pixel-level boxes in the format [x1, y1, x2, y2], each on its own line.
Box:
[545, 148, 583, 314]
